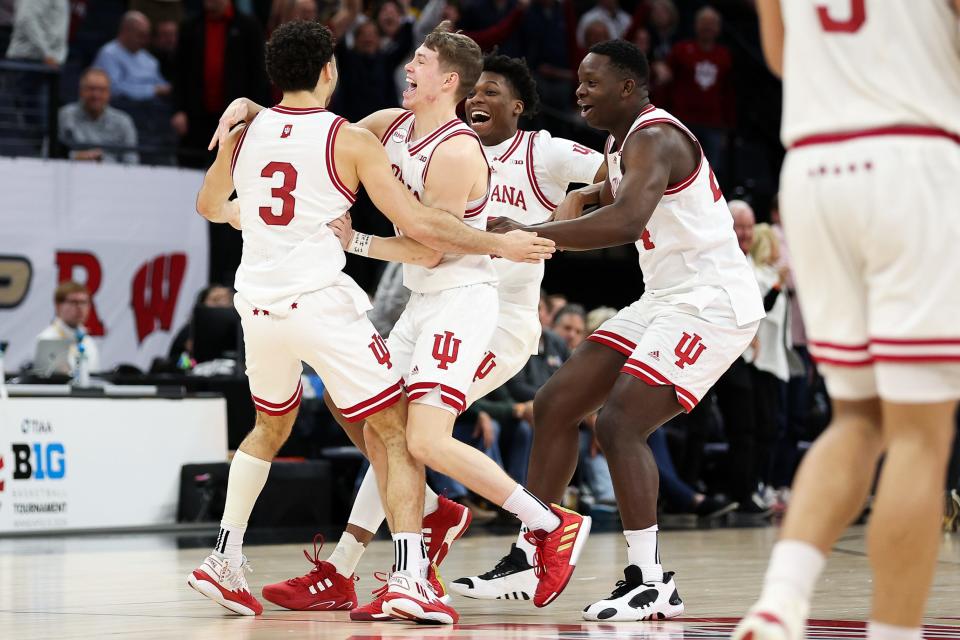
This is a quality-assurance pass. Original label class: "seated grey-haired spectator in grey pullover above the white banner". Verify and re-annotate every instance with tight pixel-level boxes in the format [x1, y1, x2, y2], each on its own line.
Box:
[59, 68, 140, 164]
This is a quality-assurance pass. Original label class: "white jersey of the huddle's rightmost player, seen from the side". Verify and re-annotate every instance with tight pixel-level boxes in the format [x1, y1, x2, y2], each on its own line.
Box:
[606, 105, 765, 327]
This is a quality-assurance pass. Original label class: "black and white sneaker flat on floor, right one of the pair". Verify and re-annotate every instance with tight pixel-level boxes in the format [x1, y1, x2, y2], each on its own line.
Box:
[583, 564, 683, 622]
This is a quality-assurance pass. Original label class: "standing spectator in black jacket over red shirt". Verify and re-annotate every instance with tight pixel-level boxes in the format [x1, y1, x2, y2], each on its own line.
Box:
[171, 0, 269, 168]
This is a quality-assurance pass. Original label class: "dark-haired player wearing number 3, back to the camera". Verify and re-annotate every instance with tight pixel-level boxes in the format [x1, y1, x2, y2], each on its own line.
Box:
[188, 21, 548, 615]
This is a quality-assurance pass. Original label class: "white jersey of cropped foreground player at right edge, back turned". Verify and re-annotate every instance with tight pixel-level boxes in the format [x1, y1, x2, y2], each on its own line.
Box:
[780, 0, 960, 147]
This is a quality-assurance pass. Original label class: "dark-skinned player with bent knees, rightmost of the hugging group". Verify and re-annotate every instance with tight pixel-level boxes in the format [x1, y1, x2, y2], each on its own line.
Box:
[488, 40, 764, 621]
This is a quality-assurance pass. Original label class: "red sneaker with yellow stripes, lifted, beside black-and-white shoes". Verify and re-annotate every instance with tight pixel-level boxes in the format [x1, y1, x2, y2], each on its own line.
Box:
[526, 504, 591, 607]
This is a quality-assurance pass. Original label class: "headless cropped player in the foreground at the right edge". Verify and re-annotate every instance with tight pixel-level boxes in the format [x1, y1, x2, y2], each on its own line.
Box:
[734, 0, 960, 640]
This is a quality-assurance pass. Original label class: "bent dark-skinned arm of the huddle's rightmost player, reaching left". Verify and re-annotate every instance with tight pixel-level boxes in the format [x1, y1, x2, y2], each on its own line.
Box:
[523, 126, 678, 250]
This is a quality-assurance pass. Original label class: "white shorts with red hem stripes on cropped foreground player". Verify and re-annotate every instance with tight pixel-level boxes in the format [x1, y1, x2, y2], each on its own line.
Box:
[780, 130, 960, 403]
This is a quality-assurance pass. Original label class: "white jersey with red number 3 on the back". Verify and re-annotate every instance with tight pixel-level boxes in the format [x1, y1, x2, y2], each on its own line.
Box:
[231, 106, 355, 311]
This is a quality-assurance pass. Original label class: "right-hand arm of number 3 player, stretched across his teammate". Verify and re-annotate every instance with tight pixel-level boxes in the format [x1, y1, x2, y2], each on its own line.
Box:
[342, 126, 554, 262]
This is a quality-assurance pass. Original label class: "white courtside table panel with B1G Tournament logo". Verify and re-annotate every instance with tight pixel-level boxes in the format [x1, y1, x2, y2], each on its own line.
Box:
[0, 397, 227, 532]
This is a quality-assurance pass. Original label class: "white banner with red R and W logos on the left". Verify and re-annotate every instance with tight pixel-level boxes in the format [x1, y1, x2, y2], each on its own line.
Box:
[0, 158, 208, 372]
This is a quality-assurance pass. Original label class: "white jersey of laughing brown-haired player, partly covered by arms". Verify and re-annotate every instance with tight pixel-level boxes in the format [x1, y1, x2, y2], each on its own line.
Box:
[381, 111, 497, 293]
